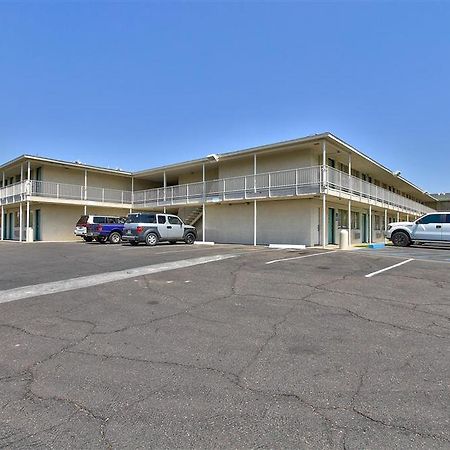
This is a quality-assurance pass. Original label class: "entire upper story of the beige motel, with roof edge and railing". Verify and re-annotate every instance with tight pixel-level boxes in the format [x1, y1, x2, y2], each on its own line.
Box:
[0, 133, 431, 214]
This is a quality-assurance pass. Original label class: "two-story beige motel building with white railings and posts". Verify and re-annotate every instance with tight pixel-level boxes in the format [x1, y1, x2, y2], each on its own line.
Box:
[0, 133, 434, 246]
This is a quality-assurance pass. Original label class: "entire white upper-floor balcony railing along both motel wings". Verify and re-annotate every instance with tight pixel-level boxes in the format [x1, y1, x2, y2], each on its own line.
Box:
[0, 166, 433, 215]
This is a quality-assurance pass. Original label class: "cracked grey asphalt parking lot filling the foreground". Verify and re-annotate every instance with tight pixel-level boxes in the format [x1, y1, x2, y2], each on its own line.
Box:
[0, 243, 450, 449]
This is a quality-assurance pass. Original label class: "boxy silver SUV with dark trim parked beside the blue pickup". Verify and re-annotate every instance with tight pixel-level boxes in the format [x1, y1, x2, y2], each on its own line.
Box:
[122, 212, 197, 246]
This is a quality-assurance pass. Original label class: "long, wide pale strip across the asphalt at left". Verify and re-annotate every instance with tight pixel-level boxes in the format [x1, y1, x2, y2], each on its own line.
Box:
[0, 254, 236, 303]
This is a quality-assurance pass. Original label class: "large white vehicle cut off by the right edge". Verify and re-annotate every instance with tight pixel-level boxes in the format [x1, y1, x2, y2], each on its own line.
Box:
[386, 212, 450, 247]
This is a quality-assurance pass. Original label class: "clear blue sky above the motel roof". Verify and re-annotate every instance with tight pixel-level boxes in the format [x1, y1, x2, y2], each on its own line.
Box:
[0, 1, 450, 192]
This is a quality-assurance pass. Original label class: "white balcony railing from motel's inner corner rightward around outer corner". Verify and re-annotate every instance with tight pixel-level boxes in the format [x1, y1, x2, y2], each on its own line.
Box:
[133, 166, 433, 215]
